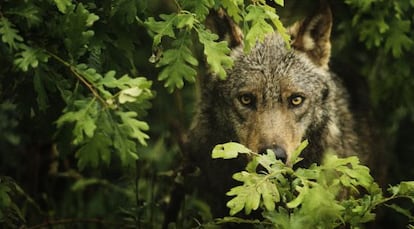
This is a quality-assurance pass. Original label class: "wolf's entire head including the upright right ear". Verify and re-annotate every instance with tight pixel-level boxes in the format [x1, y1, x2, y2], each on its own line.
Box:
[206, 5, 341, 165]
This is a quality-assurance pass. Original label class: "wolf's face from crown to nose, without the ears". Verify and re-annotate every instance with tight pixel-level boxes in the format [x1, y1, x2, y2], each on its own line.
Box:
[218, 35, 329, 161]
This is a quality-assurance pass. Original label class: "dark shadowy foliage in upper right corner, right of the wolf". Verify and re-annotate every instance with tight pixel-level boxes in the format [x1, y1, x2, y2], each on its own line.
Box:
[337, 0, 414, 133]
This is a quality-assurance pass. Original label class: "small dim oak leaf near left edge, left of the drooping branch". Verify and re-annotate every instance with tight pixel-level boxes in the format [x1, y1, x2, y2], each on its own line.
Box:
[14, 46, 49, 72]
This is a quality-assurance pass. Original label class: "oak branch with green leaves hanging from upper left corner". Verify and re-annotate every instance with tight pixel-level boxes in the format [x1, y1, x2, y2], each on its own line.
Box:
[0, 1, 153, 169]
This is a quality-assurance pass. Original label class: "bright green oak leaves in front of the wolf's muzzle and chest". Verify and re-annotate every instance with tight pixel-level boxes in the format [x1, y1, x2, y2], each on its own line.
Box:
[212, 141, 414, 228]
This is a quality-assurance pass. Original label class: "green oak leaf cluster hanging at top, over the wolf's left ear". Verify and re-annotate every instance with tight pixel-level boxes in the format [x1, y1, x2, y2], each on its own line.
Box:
[145, 0, 289, 92]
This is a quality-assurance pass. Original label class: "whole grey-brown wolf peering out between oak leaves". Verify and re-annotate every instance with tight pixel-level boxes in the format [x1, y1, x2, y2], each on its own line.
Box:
[187, 4, 376, 220]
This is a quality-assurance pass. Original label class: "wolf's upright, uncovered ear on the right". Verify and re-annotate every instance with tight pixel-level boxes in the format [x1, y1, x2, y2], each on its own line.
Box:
[289, 4, 332, 68]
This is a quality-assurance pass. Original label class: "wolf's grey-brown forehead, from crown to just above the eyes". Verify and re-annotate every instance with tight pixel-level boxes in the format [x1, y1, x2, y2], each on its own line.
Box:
[229, 34, 327, 94]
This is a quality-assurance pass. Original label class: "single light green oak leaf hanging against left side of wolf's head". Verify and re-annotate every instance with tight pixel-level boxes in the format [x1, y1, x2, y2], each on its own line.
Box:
[197, 28, 233, 79]
